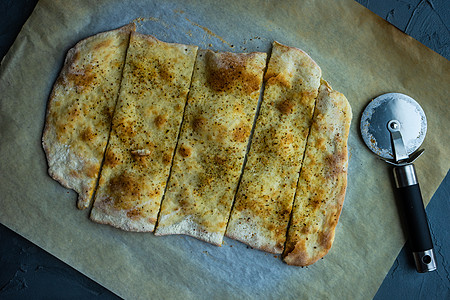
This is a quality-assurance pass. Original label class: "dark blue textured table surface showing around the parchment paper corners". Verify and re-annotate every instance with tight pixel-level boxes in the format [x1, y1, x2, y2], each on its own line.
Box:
[0, 0, 450, 299]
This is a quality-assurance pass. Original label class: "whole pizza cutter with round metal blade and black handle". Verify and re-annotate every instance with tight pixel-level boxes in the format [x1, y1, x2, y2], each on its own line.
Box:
[360, 93, 436, 273]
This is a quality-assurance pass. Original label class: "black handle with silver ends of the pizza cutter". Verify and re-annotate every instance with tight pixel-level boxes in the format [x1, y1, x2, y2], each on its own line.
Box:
[394, 164, 436, 273]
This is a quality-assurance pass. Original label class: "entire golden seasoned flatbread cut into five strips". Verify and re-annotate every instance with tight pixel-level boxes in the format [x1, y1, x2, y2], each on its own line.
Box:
[42, 28, 352, 266]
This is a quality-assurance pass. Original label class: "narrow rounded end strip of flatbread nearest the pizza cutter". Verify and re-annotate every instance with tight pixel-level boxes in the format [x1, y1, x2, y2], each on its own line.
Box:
[283, 80, 352, 266]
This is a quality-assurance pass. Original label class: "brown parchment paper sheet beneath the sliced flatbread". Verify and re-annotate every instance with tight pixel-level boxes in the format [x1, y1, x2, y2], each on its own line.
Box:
[0, 0, 450, 299]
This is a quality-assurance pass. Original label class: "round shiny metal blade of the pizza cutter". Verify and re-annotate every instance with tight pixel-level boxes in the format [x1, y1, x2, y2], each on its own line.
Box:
[360, 93, 427, 159]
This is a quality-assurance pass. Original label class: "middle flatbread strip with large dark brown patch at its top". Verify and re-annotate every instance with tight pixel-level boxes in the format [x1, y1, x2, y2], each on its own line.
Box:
[155, 50, 267, 245]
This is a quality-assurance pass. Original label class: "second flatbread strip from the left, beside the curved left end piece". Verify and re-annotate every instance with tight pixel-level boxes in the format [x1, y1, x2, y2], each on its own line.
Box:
[91, 33, 198, 231]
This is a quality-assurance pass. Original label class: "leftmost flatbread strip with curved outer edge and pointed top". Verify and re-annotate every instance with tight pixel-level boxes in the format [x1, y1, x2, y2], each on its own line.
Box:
[42, 24, 135, 209]
